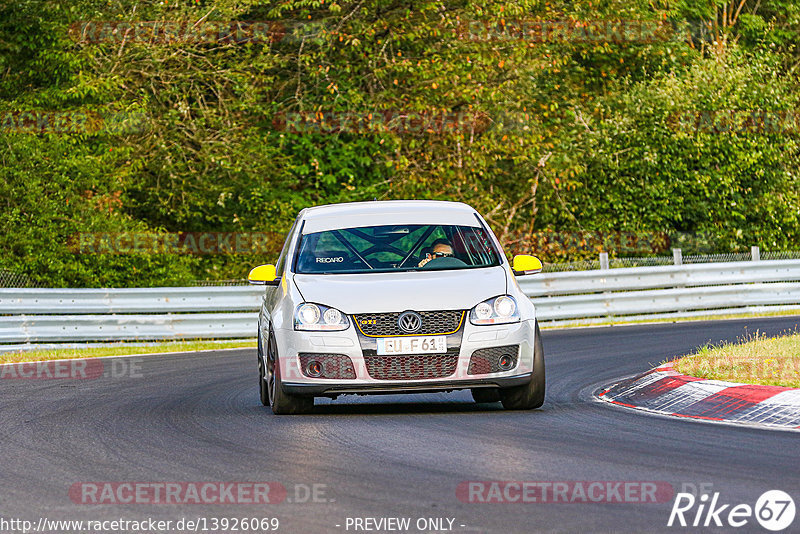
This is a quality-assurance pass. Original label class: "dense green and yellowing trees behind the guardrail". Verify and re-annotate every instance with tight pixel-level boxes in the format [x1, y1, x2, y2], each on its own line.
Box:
[0, 0, 800, 286]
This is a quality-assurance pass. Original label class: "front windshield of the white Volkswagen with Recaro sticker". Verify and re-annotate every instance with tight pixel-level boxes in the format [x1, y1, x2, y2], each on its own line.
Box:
[294, 224, 500, 274]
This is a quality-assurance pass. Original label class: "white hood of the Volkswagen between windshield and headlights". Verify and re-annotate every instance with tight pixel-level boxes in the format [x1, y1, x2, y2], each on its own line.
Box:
[294, 267, 506, 314]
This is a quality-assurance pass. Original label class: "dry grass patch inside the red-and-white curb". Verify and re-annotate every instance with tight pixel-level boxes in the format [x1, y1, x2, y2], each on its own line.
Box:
[675, 332, 800, 388]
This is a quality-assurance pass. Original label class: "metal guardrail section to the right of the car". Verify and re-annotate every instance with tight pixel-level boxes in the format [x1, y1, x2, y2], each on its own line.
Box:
[519, 260, 800, 324]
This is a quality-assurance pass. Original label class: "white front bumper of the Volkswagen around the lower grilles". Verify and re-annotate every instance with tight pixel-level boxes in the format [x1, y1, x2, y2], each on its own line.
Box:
[275, 319, 536, 396]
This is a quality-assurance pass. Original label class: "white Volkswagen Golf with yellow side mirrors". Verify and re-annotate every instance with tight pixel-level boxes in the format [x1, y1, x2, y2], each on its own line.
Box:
[248, 200, 545, 414]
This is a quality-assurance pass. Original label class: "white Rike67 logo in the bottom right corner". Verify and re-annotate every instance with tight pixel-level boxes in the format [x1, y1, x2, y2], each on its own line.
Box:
[667, 490, 795, 532]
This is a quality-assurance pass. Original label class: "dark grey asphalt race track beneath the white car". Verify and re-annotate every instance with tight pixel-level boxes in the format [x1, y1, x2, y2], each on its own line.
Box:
[0, 317, 800, 533]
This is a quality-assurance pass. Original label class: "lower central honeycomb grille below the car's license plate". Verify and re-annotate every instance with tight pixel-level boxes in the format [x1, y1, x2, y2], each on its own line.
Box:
[364, 348, 458, 380]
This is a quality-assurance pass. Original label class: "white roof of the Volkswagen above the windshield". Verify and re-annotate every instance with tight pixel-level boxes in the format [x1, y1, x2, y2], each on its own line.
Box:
[300, 200, 480, 234]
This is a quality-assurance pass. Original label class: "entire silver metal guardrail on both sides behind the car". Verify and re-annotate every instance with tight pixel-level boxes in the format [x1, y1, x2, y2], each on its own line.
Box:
[0, 260, 800, 350]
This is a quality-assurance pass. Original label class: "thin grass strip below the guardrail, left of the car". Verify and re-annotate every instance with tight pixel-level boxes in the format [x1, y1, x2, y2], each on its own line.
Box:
[0, 340, 256, 363]
